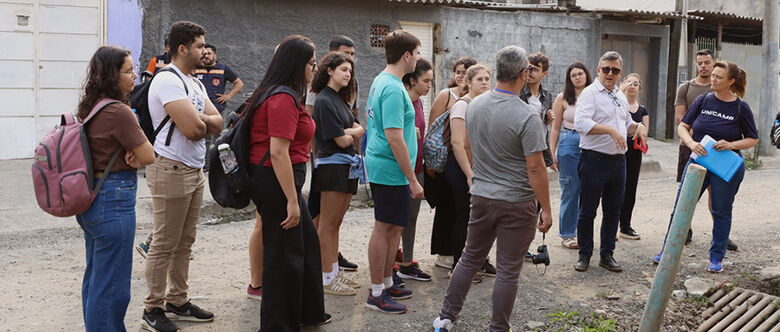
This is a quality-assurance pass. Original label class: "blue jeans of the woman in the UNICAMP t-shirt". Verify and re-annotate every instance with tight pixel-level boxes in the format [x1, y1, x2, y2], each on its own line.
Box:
[662, 159, 745, 262]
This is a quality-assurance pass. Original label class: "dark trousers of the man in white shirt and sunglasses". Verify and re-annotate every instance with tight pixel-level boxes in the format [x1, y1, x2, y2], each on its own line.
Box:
[577, 150, 626, 257]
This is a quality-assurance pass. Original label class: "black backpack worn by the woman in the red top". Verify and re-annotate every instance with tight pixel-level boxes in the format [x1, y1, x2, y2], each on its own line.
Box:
[206, 85, 298, 209]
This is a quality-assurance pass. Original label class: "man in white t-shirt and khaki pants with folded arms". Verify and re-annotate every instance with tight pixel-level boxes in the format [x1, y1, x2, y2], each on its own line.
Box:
[141, 21, 222, 332]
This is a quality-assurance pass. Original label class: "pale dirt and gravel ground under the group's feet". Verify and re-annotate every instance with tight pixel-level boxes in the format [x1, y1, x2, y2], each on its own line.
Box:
[0, 169, 780, 331]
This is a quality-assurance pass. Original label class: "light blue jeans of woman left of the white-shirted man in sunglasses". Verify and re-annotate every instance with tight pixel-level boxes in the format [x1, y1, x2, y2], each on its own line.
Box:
[557, 129, 580, 239]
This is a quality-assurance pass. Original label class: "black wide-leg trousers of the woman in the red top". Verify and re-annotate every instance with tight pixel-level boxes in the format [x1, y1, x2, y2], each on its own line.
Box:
[253, 164, 325, 332]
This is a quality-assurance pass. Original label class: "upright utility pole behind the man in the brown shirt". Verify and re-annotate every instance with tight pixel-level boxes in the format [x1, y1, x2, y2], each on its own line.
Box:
[665, 0, 688, 138]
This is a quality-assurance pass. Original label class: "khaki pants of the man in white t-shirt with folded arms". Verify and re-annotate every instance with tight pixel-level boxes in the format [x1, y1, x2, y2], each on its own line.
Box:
[144, 156, 206, 310]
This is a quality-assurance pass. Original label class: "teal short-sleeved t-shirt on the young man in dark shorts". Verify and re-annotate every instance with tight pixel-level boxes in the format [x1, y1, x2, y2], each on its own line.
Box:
[366, 72, 417, 186]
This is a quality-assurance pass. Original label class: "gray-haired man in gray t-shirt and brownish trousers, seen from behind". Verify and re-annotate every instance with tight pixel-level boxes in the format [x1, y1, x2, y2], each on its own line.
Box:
[433, 46, 552, 331]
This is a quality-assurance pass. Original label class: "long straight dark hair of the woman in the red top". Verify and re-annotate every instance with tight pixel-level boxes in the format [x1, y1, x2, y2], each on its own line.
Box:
[247, 35, 315, 107]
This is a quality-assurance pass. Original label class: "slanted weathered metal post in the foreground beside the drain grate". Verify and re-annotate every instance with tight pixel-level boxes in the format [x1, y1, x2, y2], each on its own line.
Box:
[639, 164, 707, 332]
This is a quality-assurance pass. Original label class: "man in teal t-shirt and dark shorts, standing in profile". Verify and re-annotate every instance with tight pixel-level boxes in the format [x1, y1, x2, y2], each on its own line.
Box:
[366, 30, 423, 314]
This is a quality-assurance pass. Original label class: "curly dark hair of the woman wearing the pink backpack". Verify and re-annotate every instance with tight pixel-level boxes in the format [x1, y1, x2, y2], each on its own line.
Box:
[76, 46, 130, 120]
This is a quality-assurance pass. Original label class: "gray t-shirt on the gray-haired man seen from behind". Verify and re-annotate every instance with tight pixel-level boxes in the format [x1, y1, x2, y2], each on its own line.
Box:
[466, 90, 547, 202]
